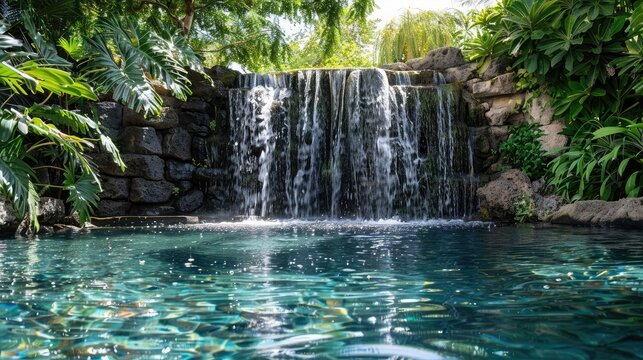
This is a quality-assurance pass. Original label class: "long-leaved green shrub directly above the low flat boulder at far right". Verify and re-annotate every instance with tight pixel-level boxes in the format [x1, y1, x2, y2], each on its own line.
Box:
[549, 118, 643, 201]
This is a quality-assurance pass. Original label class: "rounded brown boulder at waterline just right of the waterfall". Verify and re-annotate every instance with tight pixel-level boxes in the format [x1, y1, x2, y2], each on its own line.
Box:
[477, 169, 533, 221]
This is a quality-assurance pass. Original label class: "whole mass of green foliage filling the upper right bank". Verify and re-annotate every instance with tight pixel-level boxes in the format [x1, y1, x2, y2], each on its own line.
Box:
[463, 0, 643, 200]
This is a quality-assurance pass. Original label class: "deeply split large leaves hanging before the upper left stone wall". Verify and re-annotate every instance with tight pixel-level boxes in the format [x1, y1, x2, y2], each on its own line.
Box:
[80, 16, 202, 115]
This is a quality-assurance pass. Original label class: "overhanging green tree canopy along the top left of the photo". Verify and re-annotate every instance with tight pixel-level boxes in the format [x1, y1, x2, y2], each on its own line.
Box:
[9, 0, 374, 70]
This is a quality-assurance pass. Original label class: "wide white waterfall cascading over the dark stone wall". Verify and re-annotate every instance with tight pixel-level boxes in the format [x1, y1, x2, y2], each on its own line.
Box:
[230, 69, 477, 219]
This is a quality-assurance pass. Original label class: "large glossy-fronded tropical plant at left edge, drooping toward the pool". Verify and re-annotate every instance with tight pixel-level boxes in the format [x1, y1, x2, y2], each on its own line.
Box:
[0, 22, 124, 231]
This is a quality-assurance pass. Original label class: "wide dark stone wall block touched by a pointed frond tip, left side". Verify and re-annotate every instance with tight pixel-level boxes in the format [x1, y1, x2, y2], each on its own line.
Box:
[92, 154, 165, 180]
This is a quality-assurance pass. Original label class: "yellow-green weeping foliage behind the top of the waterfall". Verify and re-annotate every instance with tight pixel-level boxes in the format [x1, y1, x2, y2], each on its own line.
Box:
[375, 10, 460, 64]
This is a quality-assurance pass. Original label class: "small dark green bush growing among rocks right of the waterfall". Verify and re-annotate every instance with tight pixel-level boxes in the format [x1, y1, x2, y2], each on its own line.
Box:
[500, 123, 545, 179]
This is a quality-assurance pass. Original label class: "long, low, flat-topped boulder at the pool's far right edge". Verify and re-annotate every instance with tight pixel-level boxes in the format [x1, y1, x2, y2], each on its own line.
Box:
[551, 197, 643, 229]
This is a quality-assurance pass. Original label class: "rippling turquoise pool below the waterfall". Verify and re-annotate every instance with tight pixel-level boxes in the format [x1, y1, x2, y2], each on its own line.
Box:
[0, 221, 643, 359]
